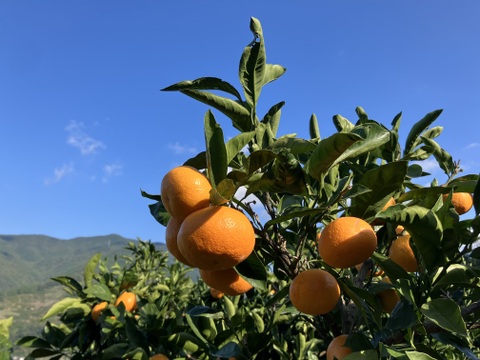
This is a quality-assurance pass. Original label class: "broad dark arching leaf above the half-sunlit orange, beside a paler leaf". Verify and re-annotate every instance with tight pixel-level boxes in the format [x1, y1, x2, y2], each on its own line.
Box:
[305, 133, 362, 179]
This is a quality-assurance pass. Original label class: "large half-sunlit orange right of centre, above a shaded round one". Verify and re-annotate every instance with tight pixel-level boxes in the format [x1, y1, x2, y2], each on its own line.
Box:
[318, 216, 377, 269]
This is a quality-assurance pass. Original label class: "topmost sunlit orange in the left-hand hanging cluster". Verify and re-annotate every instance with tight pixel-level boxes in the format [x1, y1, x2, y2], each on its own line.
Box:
[161, 166, 212, 219]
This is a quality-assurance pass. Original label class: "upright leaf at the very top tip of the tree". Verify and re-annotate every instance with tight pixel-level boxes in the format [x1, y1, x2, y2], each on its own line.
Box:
[239, 17, 266, 109]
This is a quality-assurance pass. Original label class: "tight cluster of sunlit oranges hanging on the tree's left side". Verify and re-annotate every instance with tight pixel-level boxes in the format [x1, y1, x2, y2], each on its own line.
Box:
[161, 166, 255, 295]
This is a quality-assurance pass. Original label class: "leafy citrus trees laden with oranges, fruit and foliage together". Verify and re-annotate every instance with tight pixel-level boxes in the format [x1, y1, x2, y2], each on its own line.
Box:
[15, 18, 480, 360]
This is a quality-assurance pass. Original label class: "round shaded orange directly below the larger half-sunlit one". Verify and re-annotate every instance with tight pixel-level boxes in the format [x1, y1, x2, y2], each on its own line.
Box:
[289, 269, 340, 315]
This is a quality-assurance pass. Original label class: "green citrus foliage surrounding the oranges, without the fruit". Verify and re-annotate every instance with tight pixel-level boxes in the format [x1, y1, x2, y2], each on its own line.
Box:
[16, 18, 480, 360]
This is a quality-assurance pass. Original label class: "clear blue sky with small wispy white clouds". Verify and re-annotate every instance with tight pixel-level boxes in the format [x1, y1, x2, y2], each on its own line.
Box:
[0, 0, 480, 242]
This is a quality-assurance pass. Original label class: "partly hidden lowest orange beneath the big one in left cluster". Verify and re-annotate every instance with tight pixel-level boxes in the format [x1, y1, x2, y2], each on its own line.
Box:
[200, 268, 253, 296]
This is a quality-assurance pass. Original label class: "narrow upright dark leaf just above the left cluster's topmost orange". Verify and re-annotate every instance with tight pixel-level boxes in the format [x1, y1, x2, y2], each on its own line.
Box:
[204, 110, 228, 188]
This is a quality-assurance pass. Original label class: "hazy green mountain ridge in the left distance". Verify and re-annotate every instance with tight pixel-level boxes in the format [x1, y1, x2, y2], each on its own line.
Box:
[0, 234, 166, 293]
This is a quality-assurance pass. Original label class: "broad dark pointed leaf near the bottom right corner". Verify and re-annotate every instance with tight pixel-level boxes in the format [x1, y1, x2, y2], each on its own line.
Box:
[420, 298, 468, 339]
